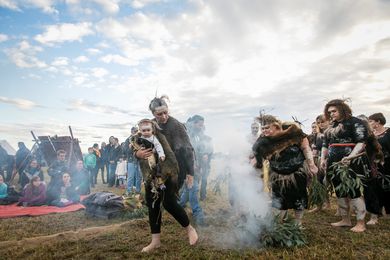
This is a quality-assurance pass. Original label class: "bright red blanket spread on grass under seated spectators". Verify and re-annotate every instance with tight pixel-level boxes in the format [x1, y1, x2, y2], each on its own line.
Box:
[0, 196, 87, 218]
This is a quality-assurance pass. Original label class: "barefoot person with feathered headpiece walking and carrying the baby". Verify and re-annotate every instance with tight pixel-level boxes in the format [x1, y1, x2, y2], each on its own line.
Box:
[136, 95, 198, 252]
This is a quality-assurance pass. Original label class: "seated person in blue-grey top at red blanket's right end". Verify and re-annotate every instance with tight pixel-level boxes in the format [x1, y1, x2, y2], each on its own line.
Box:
[47, 173, 80, 207]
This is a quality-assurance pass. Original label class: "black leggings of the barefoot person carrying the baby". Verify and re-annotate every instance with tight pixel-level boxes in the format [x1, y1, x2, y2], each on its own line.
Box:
[145, 178, 190, 234]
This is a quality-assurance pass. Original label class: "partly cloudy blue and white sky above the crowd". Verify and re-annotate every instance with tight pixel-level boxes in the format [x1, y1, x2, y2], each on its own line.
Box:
[0, 0, 390, 151]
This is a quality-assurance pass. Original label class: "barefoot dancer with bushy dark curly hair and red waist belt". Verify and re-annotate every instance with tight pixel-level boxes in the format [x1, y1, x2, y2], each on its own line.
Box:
[321, 99, 368, 232]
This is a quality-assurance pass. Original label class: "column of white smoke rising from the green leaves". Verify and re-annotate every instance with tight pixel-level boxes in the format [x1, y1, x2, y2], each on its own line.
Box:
[201, 123, 271, 248]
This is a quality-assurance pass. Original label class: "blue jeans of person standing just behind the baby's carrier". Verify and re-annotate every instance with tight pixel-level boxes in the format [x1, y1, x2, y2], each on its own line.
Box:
[179, 177, 204, 224]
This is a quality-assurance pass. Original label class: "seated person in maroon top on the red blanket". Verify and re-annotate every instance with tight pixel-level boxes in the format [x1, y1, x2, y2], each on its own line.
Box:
[18, 175, 46, 207]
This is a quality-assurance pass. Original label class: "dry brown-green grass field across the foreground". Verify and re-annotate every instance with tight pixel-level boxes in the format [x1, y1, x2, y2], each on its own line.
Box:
[0, 179, 390, 259]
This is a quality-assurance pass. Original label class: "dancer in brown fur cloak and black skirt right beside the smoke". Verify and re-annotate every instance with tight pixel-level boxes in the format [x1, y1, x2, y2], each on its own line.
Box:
[253, 115, 318, 224]
